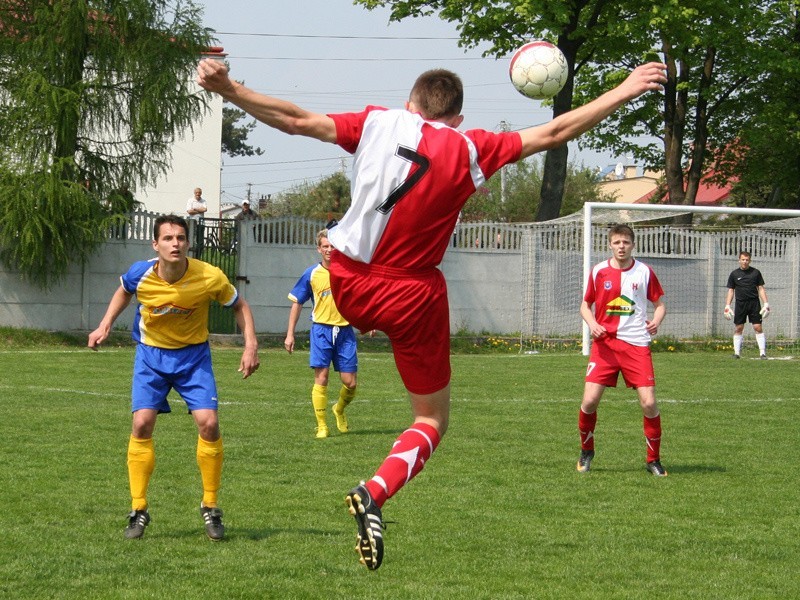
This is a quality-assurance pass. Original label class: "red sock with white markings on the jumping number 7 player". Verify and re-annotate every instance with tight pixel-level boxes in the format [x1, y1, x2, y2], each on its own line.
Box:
[365, 423, 440, 507]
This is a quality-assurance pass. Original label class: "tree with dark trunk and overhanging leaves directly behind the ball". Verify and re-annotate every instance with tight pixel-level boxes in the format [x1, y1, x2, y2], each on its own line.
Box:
[355, 0, 630, 221]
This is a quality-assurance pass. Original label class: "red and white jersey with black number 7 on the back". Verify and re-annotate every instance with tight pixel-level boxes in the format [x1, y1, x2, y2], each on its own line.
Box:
[328, 106, 522, 269]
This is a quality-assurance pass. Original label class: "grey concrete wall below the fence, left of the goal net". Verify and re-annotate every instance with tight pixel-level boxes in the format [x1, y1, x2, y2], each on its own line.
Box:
[0, 234, 522, 333]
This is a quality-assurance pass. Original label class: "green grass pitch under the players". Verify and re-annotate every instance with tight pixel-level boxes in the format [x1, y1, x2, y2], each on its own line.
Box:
[0, 346, 800, 600]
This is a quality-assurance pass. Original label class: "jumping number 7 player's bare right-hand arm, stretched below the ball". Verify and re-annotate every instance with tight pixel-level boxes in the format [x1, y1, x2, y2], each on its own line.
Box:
[520, 62, 667, 158]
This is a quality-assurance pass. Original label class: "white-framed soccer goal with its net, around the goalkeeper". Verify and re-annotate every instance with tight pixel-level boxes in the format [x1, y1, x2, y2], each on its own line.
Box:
[520, 202, 800, 355]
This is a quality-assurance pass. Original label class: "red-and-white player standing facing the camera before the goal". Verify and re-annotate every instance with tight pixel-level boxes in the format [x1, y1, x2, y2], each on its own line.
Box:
[577, 225, 667, 477]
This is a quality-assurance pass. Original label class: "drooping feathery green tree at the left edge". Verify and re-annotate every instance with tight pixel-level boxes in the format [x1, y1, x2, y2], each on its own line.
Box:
[0, 0, 211, 287]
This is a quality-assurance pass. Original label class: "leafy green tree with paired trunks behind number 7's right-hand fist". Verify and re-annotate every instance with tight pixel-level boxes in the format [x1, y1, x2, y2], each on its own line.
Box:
[580, 0, 780, 216]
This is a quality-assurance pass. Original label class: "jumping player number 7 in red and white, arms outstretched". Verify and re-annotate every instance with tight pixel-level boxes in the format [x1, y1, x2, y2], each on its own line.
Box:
[198, 60, 666, 570]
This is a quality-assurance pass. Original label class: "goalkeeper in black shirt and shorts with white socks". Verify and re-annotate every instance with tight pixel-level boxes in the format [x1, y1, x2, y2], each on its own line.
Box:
[724, 251, 769, 360]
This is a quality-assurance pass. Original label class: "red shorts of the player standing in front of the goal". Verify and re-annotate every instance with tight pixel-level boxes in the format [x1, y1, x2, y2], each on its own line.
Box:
[586, 336, 656, 388]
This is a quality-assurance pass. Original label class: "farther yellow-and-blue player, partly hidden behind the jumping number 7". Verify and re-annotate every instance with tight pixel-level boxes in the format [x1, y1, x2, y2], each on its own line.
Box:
[284, 229, 358, 438]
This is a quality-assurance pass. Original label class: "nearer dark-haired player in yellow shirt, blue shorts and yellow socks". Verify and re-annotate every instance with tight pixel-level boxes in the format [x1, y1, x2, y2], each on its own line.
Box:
[88, 215, 259, 540]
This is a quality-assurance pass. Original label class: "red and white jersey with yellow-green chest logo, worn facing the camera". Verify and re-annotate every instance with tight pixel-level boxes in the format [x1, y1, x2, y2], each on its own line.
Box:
[583, 260, 664, 346]
